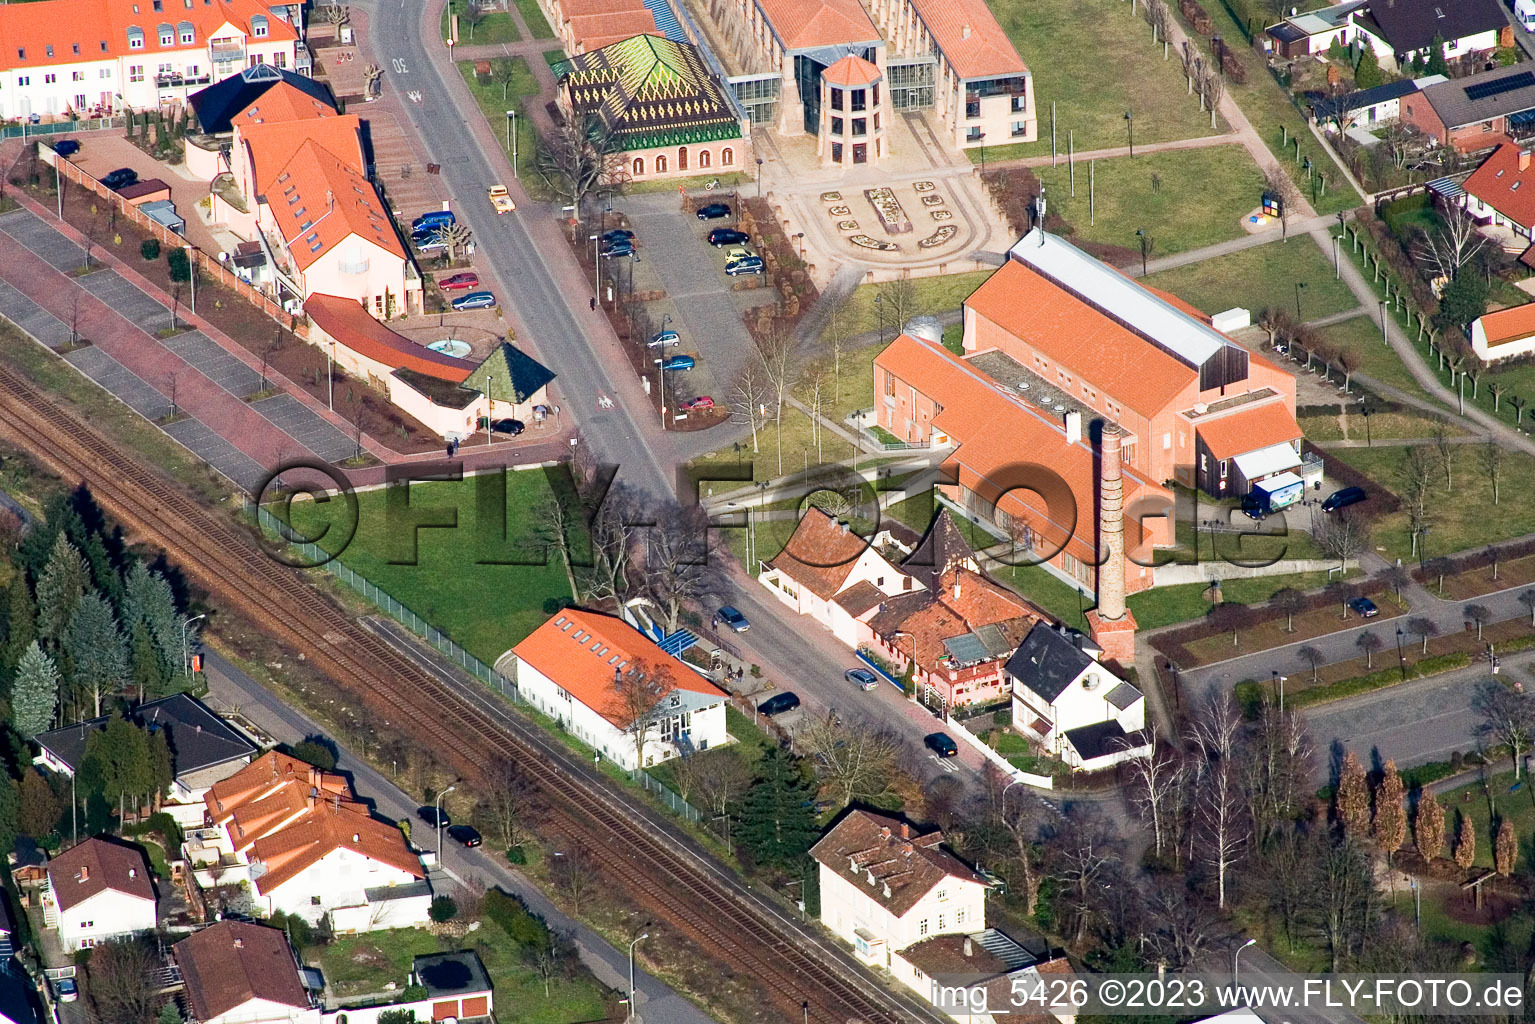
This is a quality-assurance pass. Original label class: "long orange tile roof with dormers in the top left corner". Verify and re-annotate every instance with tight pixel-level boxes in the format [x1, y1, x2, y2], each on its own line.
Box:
[0, 0, 298, 68]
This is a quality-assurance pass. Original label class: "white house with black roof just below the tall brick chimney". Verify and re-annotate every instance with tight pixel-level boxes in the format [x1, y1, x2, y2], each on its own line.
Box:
[1007, 622, 1148, 769]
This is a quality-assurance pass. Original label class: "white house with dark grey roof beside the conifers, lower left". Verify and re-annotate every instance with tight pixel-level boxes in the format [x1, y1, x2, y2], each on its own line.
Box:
[35, 694, 256, 826]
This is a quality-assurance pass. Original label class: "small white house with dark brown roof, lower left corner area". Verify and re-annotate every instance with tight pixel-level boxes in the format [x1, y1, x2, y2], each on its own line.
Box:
[43, 838, 157, 952]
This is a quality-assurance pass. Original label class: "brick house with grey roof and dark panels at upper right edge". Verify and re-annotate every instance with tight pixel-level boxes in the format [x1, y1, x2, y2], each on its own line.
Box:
[1401, 62, 1535, 154]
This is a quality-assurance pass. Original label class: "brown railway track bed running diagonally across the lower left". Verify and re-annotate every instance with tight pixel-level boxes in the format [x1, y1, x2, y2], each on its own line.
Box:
[0, 367, 944, 1024]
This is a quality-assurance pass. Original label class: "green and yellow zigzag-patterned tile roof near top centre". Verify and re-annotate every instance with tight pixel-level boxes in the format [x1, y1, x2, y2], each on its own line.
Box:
[554, 35, 741, 149]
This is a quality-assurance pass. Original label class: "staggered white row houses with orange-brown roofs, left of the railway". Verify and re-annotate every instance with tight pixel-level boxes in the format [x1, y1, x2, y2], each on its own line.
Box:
[183, 751, 431, 932]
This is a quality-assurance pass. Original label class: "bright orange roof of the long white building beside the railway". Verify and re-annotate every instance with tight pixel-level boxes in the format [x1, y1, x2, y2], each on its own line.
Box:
[513, 608, 726, 729]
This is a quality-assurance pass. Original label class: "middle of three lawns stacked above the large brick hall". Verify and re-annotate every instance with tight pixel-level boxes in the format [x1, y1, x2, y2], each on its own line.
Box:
[1035, 146, 1263, 258]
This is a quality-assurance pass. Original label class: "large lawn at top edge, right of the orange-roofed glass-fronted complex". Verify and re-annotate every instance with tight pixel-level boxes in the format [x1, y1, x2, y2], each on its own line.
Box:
[966, 0, 1225, 161]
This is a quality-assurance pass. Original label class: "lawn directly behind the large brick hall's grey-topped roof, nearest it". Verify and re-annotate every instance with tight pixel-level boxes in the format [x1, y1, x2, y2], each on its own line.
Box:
[1147, 235, 1358, 319]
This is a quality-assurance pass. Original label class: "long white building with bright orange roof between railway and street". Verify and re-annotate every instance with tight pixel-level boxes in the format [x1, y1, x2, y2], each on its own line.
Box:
[511, 608, 731, 771]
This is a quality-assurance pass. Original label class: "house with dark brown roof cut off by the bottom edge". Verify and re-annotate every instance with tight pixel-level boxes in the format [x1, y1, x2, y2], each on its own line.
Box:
[170, 921, 321, 1024]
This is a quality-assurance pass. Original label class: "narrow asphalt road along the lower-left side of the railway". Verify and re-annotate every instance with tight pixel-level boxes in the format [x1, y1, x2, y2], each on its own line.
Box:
[204, 651, 714, 1024]
